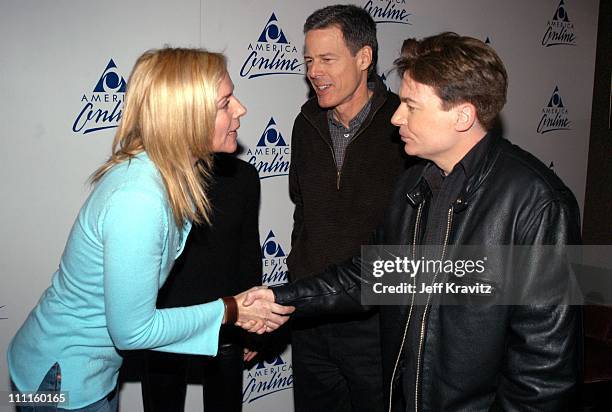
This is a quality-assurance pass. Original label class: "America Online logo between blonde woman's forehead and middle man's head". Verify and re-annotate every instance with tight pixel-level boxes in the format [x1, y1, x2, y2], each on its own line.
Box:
[240, 13, 304, 79]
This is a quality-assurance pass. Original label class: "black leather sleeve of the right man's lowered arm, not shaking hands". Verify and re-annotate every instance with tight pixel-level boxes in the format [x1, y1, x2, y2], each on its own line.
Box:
[492, 195, 582, 411]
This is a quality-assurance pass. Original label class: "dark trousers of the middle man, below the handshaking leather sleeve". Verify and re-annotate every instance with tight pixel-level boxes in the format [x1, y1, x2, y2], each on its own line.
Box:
[291, 314, 384, 412]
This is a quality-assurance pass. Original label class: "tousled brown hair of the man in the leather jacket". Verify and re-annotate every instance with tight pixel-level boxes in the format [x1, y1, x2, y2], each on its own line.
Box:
[395, 32, 508, 130]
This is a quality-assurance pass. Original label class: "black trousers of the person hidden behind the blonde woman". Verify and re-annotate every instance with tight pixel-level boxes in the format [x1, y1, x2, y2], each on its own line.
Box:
[142, 344, 244, 412]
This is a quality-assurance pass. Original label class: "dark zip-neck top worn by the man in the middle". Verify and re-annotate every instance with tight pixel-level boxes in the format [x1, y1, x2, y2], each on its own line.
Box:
[287, 77, 408, 280]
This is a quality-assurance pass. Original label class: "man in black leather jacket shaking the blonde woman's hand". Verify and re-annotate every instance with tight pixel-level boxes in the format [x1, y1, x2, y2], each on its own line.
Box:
[251, 33, 581, 411]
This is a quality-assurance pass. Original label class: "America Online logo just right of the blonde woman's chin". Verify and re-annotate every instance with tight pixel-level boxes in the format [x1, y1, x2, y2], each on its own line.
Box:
[246, 117, 291, 179]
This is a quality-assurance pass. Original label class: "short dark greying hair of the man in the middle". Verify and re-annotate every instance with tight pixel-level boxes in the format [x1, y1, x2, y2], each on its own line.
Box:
[304, 4, 378, 76]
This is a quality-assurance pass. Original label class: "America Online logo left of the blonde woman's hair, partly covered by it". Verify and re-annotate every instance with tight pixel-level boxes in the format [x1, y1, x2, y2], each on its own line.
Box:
[72, 59, 126, 134]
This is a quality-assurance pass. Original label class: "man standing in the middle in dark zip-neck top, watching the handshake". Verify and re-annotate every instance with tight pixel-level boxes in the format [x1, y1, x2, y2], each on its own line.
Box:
[287, 5, 406, 412]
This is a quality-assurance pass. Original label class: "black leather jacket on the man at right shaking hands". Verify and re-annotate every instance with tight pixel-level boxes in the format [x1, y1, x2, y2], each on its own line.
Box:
[274, 136, 581, 411]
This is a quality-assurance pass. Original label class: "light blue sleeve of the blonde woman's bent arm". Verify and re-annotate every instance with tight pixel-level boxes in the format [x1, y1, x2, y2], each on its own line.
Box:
[102, 191, 224, 355]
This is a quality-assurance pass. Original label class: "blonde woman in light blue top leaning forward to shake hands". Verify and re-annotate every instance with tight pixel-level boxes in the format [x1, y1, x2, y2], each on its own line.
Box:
[8, 48, 292, 411]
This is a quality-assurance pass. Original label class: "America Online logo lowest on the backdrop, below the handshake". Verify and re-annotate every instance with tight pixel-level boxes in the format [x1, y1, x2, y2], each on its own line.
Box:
[242, 355, 293, 403]
